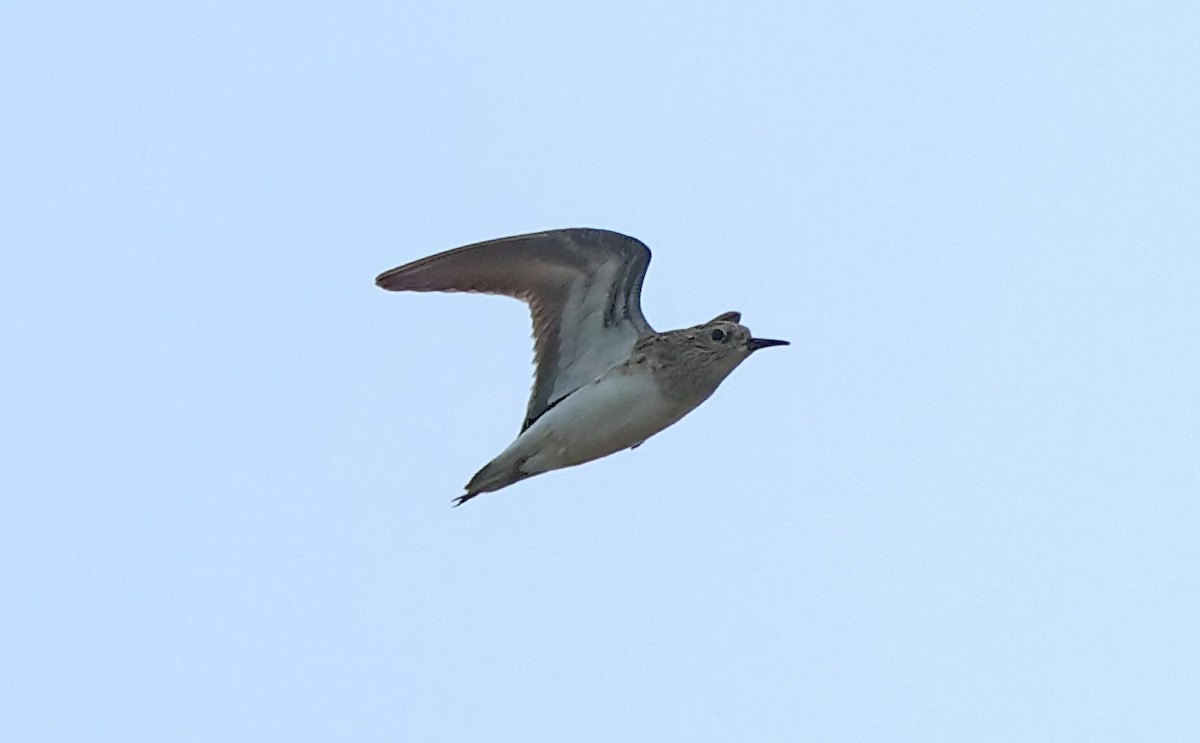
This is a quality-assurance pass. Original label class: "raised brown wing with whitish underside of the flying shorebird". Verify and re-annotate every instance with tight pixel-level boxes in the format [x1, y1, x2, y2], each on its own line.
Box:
[376, 228, 654, 431]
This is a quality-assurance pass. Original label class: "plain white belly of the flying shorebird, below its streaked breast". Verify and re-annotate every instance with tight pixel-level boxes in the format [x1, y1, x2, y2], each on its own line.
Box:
[521, 373, 686, 472]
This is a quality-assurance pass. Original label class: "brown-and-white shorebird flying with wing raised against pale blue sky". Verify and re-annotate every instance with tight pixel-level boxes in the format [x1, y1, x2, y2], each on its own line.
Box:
[376, 228, 788, 505]
